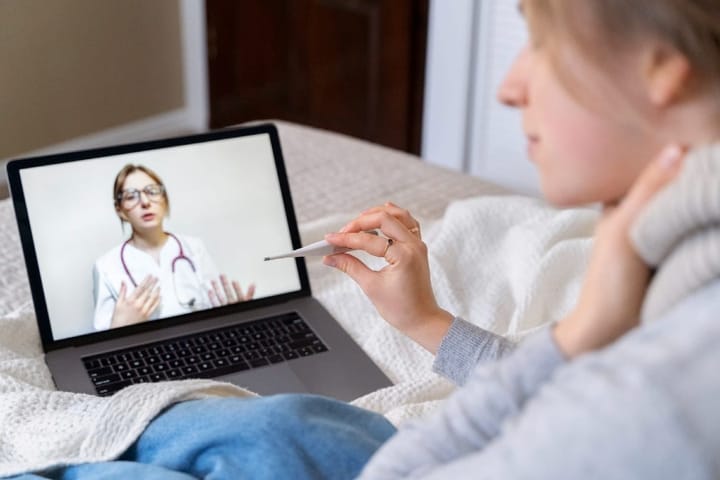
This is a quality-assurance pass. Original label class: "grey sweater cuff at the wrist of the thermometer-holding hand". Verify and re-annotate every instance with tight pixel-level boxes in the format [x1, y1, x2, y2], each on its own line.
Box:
[432, 317, 515, 385]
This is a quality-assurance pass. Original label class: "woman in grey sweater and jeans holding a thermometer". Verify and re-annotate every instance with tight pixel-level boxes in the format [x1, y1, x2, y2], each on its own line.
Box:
[12, 0, 720, 479]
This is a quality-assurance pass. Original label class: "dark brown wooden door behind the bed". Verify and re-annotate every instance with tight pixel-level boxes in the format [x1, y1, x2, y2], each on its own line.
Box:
[206, 0, 428, 153]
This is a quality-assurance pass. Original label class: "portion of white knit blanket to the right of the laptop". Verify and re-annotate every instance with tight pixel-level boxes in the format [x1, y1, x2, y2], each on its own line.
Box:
[303, 196, 598, 424]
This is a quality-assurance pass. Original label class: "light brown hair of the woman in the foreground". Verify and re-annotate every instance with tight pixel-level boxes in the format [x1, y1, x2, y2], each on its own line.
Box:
[521, 0, 720, 88]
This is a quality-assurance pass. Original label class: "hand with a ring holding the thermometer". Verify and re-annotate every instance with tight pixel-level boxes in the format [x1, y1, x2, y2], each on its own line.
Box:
[323, 202, 453, 353]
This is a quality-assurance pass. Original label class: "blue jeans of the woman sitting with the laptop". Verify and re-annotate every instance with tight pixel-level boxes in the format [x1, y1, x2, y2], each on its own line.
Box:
[8, 395, 395, 480]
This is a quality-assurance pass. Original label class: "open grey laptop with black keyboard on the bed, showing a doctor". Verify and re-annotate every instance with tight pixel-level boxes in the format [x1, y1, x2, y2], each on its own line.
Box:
[7, 124, 391, 401]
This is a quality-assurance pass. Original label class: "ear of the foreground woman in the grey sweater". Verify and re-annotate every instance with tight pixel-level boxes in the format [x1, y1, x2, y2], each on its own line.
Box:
[645, 46, 691, 108]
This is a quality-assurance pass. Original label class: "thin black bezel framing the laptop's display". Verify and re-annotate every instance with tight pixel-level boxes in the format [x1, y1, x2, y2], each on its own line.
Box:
[7, 123, 311, 352]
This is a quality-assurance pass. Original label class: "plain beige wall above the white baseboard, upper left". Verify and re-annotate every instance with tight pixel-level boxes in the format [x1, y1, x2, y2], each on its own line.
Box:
[0, 0, 184, 159]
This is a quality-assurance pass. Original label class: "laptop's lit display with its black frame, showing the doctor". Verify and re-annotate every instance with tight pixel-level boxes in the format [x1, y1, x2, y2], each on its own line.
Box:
[8, 126, 306, 342]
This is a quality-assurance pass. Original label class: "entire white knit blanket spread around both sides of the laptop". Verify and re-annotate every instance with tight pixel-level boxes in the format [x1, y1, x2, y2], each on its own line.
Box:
[0, 192, 597, 475]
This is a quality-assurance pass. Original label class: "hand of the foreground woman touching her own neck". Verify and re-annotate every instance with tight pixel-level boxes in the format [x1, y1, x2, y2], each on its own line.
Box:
[554, 146, 683, 358]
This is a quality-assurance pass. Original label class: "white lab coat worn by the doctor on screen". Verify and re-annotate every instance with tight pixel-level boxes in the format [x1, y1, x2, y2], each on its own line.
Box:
[93, 235, 219, 330]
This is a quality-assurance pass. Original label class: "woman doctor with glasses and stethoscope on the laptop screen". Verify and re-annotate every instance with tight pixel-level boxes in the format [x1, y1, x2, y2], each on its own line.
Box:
[93, 164, 255, 330]
